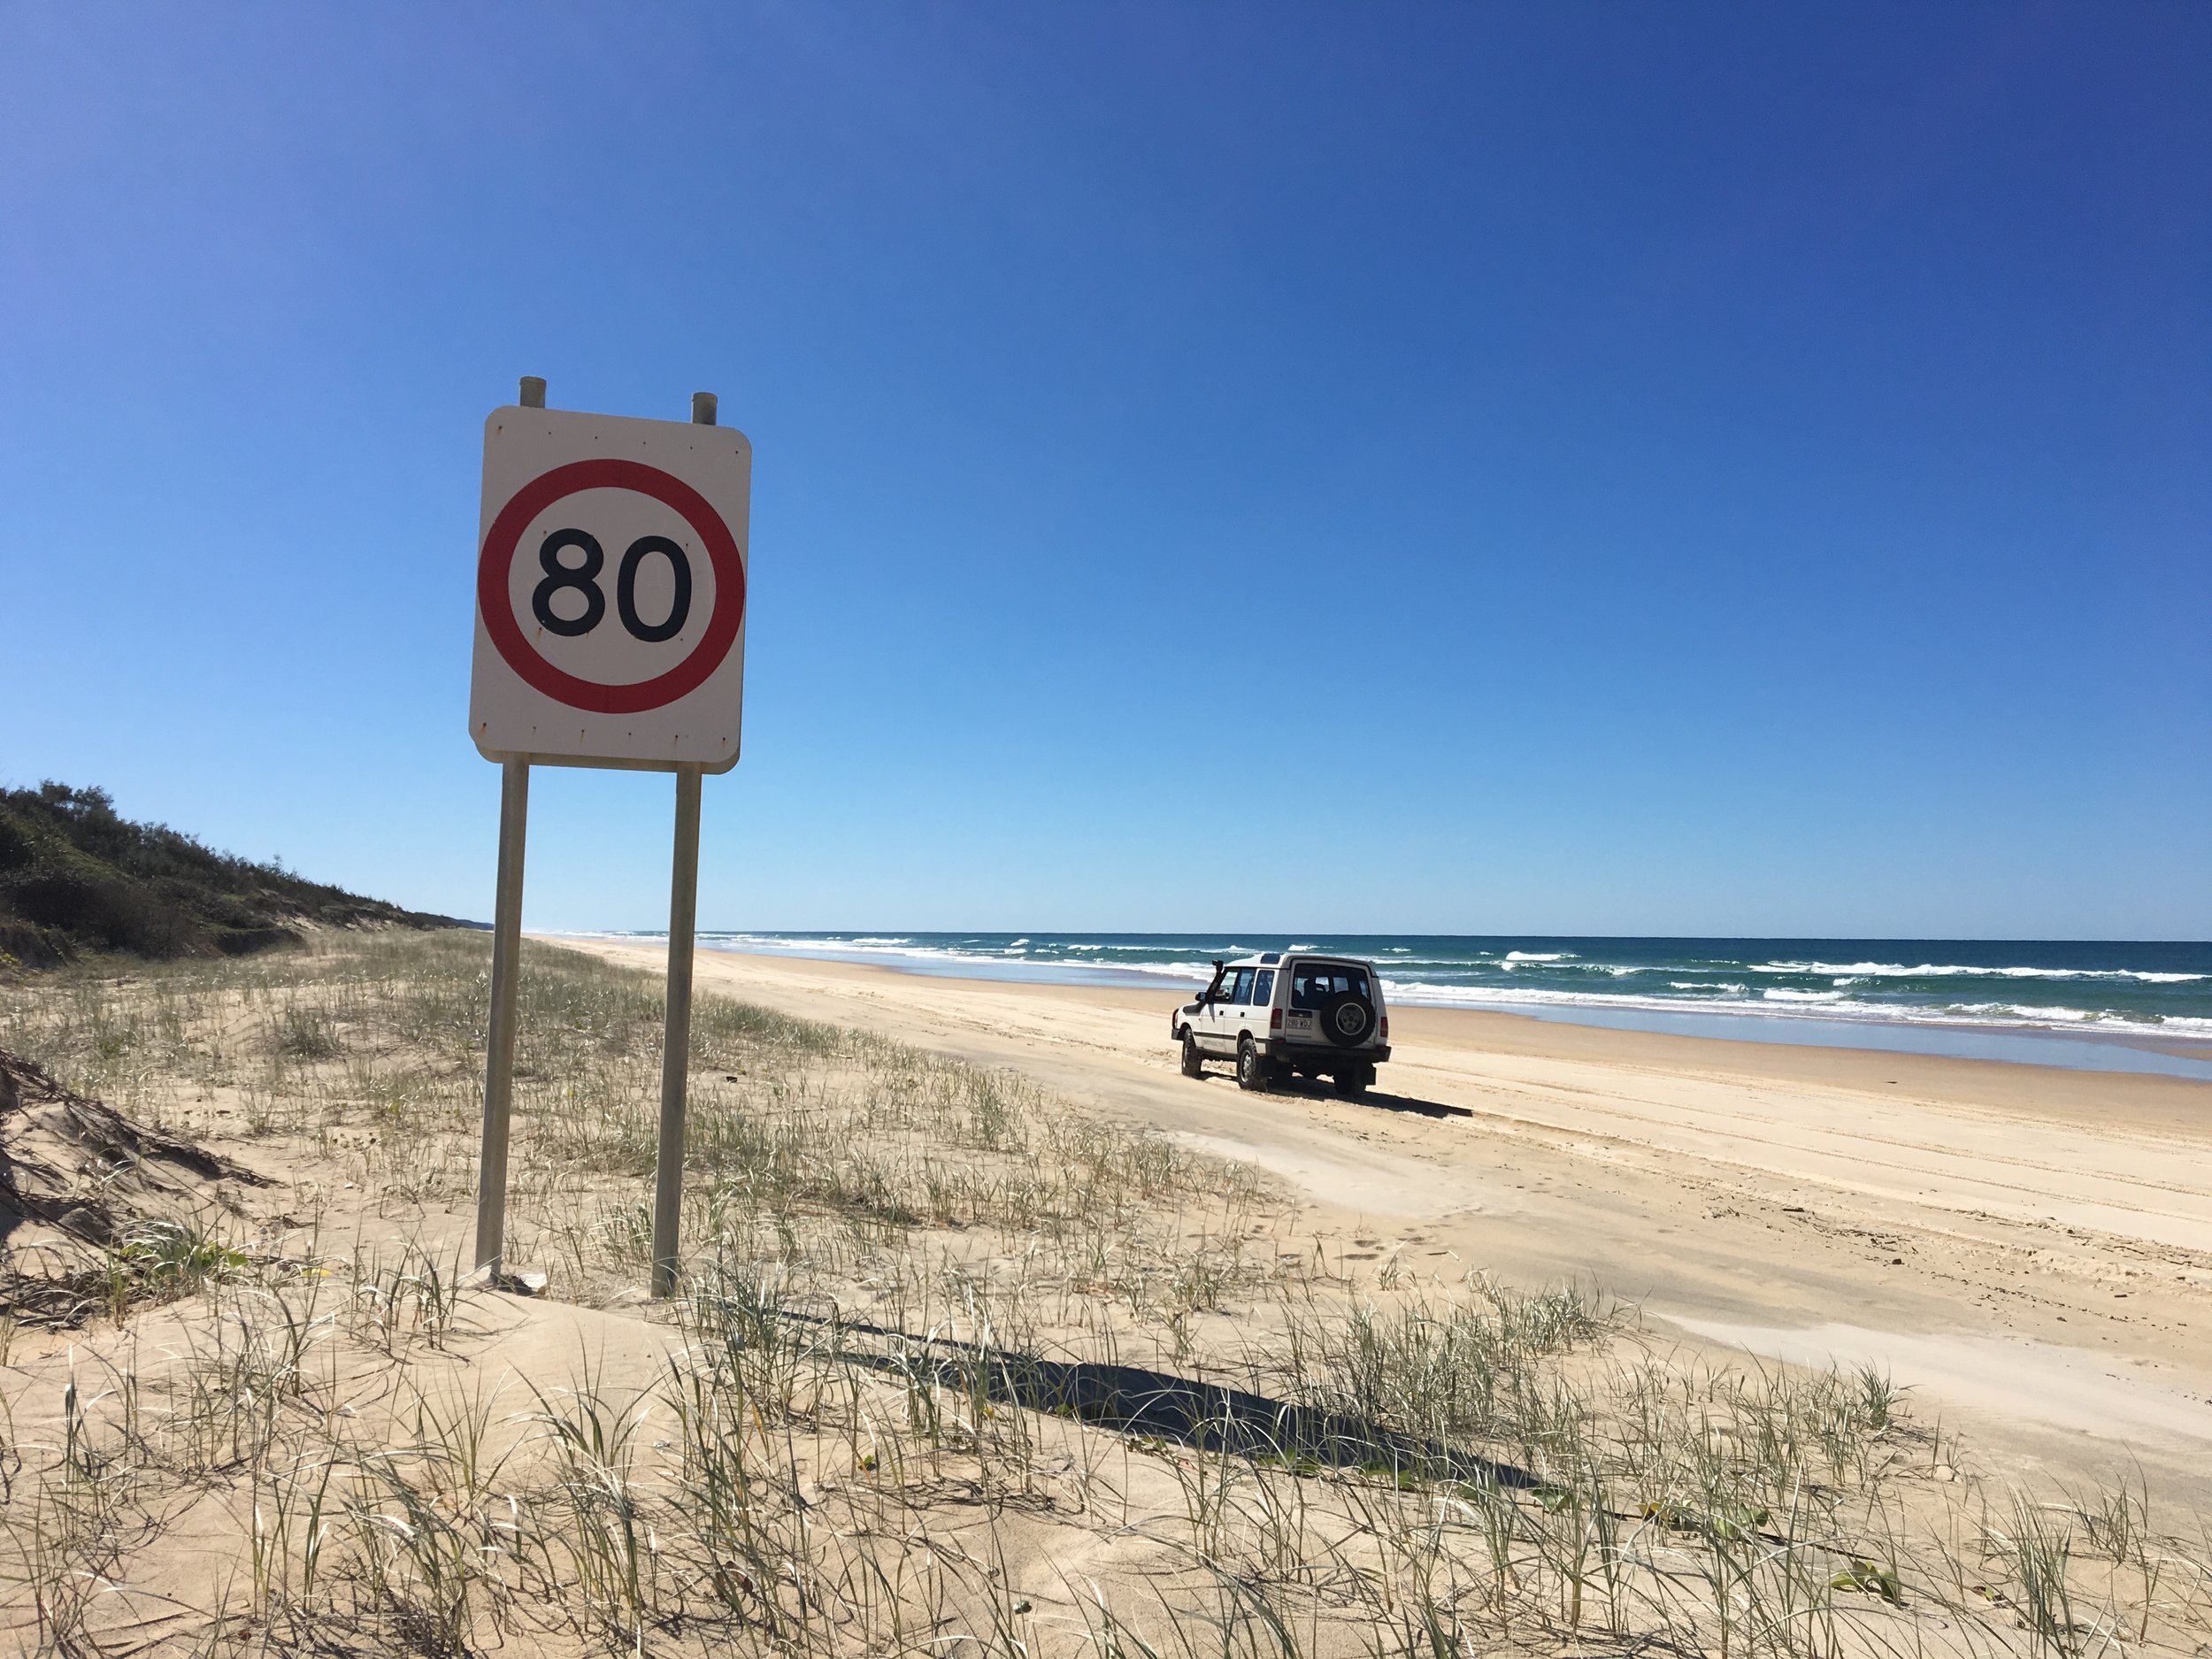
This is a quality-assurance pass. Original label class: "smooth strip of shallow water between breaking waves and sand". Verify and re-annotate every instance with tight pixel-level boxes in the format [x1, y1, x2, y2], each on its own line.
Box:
[566, 932, 2212, 1082]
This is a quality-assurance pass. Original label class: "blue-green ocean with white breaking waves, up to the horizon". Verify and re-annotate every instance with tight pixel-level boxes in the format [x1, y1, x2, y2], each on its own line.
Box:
[588, 933, 2212, 1079]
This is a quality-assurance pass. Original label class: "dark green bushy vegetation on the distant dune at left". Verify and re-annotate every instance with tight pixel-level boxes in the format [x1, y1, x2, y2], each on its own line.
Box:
[0, 783, 456, 969]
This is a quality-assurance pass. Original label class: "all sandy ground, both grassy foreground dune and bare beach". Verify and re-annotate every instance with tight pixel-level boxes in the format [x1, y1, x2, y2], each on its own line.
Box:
[0, 929, 2212, 1659]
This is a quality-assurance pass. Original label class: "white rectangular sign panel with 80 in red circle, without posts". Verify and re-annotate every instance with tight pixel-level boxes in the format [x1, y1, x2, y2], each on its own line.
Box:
[469, 407, 752, 772]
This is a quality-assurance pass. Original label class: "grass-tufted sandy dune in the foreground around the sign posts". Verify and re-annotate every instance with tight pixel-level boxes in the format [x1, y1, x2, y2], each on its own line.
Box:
[0, 933, 2212, 1659]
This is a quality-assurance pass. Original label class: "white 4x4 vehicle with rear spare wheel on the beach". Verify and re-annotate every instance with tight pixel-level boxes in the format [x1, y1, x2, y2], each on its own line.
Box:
[1171, 951, 1389, 1095]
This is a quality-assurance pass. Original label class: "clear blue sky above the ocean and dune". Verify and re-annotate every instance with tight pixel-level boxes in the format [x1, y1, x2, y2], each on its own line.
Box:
[0, 3, 2212, 938]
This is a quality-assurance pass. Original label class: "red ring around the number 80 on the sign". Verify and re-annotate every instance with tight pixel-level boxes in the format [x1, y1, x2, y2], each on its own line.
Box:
[476, 460, 746, 715]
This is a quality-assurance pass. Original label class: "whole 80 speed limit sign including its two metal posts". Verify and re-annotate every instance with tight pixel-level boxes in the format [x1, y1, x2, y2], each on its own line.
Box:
[469, 376, 752, 1296]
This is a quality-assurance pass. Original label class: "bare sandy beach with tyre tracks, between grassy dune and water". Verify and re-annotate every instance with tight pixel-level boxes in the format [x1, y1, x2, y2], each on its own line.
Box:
[569, 941, 2212, 1502]
